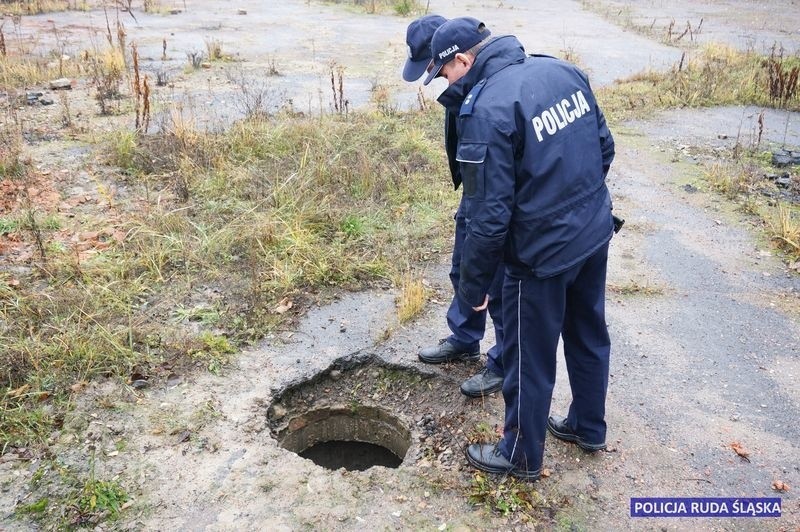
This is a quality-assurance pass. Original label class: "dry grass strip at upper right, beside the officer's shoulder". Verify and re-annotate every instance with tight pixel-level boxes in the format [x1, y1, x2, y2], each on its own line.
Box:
[597, 44, 800, 120]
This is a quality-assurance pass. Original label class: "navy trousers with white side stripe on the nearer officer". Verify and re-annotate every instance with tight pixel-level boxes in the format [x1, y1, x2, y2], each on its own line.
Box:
[499, 244, 611, 471]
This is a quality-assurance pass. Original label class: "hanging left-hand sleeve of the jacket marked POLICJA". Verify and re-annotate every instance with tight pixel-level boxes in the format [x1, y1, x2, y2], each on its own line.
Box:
[457, 116, 515, 311]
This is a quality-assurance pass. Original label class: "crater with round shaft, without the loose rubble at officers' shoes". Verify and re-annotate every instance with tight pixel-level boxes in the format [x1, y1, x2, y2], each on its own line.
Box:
[267, 356, 446, 471]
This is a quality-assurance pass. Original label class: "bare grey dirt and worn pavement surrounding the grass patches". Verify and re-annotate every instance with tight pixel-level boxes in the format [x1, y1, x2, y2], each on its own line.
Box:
[0, 0, 800, 531]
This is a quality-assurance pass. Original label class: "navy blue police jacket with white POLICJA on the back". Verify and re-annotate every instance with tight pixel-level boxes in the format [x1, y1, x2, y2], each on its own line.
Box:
[438, 35, 614, 307]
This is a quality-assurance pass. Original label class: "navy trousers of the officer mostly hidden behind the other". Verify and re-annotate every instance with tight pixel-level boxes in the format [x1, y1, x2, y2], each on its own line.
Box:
[447, 196, 504, 375]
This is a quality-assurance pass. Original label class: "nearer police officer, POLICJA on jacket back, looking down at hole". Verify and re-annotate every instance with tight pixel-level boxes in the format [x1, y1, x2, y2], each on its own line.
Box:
[425, 17, 614, 480]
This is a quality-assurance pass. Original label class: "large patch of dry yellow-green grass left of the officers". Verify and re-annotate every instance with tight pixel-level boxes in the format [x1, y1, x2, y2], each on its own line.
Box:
[0, 106, 456, 456]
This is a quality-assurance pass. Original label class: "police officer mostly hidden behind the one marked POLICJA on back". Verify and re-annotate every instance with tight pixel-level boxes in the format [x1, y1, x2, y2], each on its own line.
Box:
[403, 15, 503, 397]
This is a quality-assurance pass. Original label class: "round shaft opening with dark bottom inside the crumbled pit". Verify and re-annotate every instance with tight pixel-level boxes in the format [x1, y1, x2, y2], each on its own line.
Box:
[278, 404, 411, 471]
